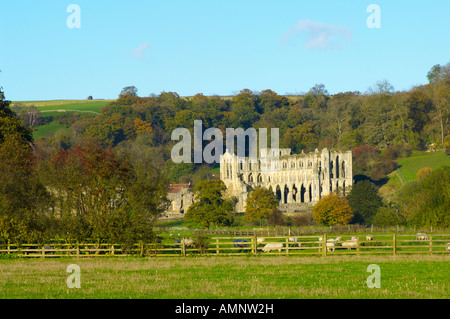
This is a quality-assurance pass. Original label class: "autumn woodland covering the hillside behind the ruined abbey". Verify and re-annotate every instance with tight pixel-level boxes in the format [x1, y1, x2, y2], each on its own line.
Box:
[28, 64, 450, 183]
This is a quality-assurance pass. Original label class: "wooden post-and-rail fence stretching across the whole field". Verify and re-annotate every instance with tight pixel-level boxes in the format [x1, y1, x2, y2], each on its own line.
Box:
[0, 233, 450, 258]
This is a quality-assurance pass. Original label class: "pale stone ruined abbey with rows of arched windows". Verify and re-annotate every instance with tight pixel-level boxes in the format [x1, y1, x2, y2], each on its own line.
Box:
[220, 148, 353, 212]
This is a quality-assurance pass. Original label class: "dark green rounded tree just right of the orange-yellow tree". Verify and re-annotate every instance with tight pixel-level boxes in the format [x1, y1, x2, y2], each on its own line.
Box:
[347, 180, 382, 225]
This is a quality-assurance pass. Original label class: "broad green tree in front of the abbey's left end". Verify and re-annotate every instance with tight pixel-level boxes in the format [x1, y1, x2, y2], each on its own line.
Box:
[184, 180, 234, 228]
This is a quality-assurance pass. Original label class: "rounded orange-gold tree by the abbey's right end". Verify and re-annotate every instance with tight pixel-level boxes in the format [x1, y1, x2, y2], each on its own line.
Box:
[313, 193, 353, 226]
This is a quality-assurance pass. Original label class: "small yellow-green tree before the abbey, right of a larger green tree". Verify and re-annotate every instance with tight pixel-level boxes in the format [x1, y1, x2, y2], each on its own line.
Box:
[245, 187, 278, 225]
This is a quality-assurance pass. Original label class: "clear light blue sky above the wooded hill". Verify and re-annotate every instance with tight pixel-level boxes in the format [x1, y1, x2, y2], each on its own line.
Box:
[0, 0, 450, 101]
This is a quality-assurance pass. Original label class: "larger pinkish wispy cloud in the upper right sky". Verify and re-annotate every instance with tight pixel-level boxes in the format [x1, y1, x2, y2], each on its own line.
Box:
[281, 20, 352, 50]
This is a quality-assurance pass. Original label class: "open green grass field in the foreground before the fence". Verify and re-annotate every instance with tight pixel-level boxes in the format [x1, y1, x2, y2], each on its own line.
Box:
[0, 256, 450, 299]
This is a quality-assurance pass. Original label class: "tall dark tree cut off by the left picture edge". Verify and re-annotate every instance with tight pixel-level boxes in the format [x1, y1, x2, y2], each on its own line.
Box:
[0, 88, 49, 242]
